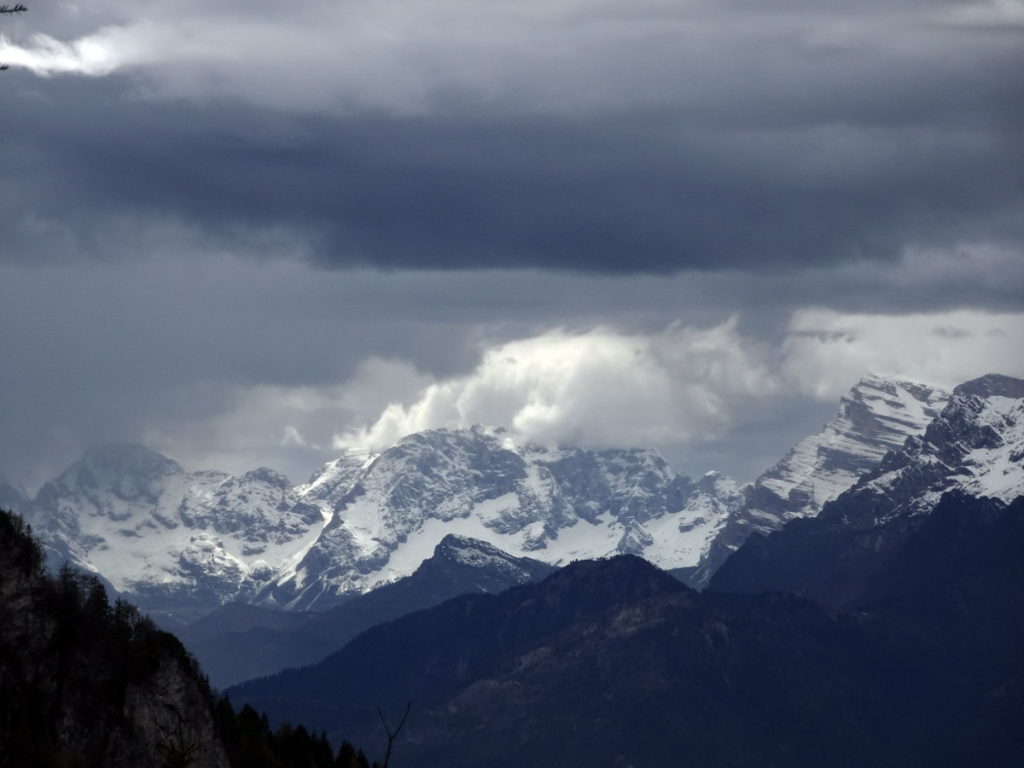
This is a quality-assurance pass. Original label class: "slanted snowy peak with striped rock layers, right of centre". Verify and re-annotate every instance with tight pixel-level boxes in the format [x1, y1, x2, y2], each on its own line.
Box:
[690, 374, 949, 587]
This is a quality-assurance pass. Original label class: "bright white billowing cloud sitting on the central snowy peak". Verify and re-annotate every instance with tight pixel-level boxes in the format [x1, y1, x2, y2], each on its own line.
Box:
[334, 318, 777, 450]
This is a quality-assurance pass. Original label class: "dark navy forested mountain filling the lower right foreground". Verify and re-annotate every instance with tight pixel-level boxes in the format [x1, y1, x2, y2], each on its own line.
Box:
[229, 528, 1024, 768]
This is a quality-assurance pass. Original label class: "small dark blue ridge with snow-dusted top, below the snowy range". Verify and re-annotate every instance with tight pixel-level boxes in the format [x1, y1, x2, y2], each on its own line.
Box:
[177, 535, 554, 687]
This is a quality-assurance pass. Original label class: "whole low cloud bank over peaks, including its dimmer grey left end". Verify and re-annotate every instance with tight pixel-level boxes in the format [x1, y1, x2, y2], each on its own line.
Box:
[145, 308, 1024, 479]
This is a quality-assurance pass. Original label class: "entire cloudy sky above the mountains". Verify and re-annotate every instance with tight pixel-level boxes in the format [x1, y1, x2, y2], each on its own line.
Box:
[0, 0, 1024, 490]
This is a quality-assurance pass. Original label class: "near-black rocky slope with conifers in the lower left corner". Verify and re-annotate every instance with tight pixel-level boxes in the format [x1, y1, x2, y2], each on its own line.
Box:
[0, 511, 376, 768]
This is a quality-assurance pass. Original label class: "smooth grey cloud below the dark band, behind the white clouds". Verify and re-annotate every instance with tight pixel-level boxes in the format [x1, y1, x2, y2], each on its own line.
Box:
[0, 256, 1024, 485]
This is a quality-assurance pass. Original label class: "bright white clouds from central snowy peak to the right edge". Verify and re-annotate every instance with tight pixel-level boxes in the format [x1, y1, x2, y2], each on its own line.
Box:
[334, 310, 1024, 460]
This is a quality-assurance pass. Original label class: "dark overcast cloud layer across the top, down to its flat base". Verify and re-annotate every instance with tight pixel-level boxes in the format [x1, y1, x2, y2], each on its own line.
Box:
[0, 0, 1024, 271]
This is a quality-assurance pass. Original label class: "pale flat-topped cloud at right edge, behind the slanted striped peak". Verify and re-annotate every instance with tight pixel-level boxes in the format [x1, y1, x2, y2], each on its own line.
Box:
[781, 309, 1024, 399]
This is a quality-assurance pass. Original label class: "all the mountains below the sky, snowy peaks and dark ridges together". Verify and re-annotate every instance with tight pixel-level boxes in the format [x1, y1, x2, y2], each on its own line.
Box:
[0, 375, 1024, 768]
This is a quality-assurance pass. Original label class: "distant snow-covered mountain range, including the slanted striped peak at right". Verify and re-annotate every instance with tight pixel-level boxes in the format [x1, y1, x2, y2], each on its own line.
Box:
[8, 375, 948, 626]
